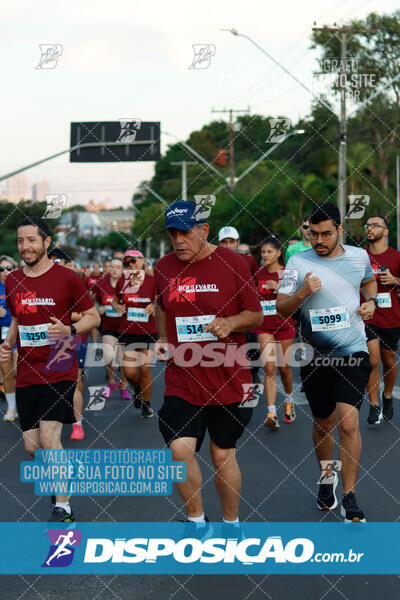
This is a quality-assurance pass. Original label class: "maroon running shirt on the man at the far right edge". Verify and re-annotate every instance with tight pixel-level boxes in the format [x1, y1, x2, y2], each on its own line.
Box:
[366, 248, 400, 329]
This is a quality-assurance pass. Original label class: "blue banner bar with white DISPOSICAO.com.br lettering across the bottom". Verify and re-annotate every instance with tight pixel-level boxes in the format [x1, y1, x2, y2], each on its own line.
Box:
[0, 523, 400, 575]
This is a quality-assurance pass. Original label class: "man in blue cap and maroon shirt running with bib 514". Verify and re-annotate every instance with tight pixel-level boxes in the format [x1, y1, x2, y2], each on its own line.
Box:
[154, 201, 263, 535]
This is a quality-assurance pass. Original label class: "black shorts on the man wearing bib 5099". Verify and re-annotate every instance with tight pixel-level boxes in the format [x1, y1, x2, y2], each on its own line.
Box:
[300, 352, 371, 419]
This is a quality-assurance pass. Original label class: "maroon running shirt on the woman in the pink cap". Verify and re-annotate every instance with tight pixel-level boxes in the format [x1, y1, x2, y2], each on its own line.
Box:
[116, 273, 157, 335]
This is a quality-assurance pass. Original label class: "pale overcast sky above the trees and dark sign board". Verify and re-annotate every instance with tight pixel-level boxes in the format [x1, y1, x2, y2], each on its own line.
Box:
[0, 0, 398, 206]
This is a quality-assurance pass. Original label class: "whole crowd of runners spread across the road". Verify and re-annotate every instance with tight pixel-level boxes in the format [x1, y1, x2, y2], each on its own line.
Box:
[0, 201, 400, 524]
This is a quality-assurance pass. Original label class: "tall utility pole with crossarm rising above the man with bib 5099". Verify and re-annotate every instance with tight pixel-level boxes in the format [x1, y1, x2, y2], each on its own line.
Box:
[313, 27, 375, 242]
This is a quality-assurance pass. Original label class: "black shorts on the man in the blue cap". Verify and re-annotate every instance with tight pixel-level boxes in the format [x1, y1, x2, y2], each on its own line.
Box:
[158, 396, 253, 452]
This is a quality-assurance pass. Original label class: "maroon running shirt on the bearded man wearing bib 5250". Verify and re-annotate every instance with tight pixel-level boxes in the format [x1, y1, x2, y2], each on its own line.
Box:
[6, 263, 93, 387]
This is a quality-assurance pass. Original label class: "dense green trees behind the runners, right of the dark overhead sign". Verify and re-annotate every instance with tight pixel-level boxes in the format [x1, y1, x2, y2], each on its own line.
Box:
[133, 10, 400, 253]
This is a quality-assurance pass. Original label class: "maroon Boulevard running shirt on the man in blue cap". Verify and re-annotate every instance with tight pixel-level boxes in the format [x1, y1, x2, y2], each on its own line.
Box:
[154, 246, 261, 406]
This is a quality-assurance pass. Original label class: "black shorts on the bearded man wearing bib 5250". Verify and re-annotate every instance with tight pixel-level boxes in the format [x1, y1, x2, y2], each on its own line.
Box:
[16, 381, 76, 431]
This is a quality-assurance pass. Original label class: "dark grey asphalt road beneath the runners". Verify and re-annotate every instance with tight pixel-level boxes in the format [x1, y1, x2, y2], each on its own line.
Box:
[0, 356, 400, 600]
